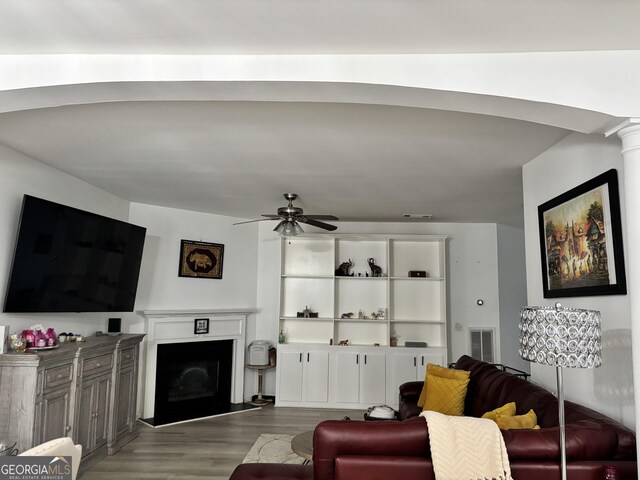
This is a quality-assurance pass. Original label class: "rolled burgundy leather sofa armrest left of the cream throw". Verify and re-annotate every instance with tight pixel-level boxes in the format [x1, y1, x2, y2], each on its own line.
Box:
[313, 420, 431, 480]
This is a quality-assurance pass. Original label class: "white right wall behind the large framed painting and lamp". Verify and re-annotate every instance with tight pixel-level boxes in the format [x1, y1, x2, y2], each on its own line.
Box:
[523, 133, 635, 428]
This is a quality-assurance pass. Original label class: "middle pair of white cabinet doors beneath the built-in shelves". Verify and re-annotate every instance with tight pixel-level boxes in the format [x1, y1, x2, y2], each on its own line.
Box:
[334, 351, 386, 406]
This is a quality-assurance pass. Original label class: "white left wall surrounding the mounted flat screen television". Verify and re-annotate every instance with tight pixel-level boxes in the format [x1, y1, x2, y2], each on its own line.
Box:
[0, 145, 136, 335]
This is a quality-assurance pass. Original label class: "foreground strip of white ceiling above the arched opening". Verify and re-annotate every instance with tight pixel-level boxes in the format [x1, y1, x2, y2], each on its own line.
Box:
[0, 0, 640, 54]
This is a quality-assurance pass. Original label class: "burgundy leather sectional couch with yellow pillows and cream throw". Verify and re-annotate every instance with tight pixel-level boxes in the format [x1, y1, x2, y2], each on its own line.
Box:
[231, 356, 638, 480]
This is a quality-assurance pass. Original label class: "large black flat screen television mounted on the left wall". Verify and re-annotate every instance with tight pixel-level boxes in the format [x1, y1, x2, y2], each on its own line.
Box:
[4, 195, 146, 313]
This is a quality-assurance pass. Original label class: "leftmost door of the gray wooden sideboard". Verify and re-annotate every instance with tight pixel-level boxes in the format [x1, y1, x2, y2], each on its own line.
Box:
[34, 388, 71, 445]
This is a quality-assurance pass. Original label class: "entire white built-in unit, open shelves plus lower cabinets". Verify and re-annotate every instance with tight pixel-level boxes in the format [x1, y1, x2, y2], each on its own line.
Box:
[276, 234, 448, 408]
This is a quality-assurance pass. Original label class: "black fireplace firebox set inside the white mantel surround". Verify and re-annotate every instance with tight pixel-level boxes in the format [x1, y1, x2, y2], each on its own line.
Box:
[154, 340, 233, 425]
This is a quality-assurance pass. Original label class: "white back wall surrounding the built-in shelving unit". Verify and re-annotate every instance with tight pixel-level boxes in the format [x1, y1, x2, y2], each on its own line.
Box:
[257, 222, 524, 394]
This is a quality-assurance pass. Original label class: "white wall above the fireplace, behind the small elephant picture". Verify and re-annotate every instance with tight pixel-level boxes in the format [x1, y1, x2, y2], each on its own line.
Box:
[129, 203, 258, 399]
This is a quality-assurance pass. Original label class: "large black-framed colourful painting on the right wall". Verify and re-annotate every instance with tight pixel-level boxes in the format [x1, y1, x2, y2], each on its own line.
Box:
[538, 169, 627, 298]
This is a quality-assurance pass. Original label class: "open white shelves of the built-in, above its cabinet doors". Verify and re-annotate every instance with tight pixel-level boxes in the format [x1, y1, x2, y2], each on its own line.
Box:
[280, 235, 447, 348]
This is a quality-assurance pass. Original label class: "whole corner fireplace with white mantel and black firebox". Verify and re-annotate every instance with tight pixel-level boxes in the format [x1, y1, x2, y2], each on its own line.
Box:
[142, 308, 256, 426]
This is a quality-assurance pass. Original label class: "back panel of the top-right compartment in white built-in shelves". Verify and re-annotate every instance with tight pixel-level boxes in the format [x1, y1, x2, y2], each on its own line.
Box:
[390, 240, 444, 278]
